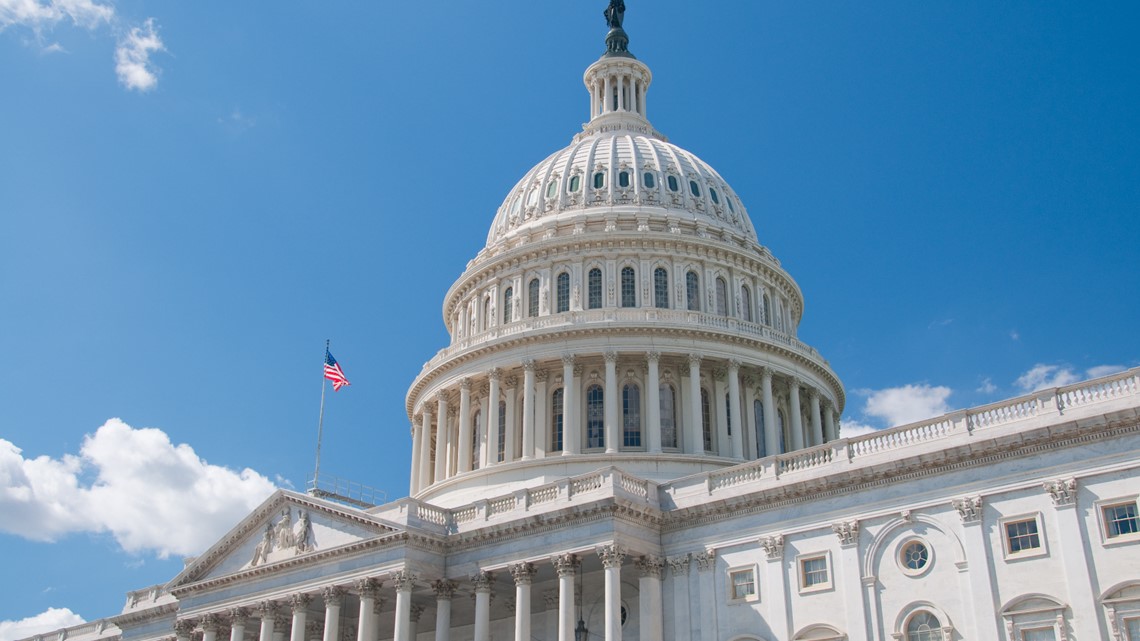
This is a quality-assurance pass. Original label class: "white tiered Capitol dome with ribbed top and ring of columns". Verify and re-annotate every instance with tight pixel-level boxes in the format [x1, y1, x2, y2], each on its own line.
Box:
[407, 16, 845, 506]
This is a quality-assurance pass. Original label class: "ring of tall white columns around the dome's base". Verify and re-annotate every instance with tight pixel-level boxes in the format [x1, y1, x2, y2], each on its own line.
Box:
[410, 351, 838, 494]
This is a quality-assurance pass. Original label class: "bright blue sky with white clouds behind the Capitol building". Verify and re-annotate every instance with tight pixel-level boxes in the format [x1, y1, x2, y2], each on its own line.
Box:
[0, 0, 1140, 639]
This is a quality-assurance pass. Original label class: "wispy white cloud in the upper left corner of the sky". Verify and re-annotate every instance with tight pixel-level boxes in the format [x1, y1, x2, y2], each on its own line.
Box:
[0, 0, 165, 91]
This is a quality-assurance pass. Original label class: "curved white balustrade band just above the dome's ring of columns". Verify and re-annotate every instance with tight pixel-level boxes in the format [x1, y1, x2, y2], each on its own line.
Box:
[423, 307, 823, 370]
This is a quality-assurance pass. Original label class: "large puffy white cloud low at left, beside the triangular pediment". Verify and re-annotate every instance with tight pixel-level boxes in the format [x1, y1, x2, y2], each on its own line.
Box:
[0, 419, 275, 558]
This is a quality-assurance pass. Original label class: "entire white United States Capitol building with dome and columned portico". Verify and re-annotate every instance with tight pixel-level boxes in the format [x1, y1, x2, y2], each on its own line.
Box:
[35, 2, 1140, 641]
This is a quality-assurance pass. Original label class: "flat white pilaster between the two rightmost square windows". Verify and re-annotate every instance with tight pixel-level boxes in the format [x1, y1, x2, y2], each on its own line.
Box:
[1043, 478, 1104, 640]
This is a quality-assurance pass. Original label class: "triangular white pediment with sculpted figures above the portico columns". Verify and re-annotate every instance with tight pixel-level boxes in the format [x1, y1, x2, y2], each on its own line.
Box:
[170, 489, 399, 589]
